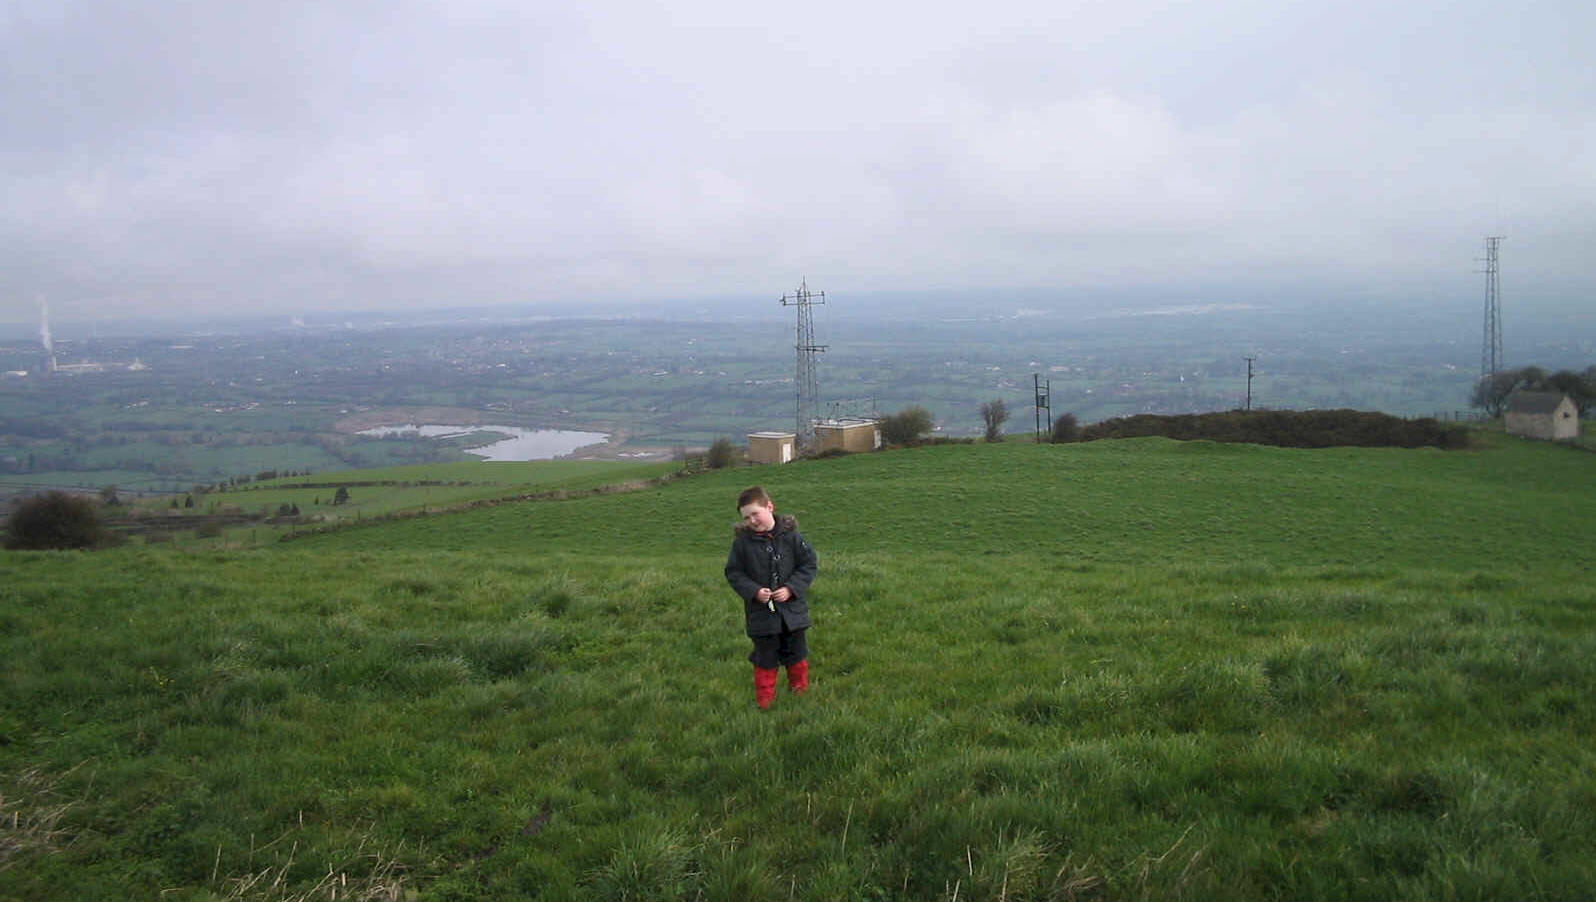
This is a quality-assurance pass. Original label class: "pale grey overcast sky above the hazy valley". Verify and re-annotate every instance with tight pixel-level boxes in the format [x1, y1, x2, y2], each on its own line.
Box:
[0, 0, 1596, 322]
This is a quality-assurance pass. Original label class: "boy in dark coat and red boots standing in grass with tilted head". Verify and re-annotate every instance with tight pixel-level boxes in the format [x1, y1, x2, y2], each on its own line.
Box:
[726, 485, 819, 709]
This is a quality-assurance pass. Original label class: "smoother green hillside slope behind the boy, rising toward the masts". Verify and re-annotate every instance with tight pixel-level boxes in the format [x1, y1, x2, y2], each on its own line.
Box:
[301, 436, 1596, 568]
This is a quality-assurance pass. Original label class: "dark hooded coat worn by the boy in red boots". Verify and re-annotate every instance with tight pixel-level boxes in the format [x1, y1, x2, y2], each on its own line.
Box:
[726, 514, 820, 637]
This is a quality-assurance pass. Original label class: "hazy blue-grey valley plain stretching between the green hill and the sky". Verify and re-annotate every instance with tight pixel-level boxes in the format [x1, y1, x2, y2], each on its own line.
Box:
[0, 292, 1593, 492]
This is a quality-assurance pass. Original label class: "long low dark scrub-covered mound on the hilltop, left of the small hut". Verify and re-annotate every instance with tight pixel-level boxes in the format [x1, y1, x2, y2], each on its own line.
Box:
[1078, 410, 1468, 449]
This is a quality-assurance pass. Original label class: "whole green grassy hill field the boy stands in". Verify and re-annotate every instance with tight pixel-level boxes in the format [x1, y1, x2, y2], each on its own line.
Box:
[0, 436, 1596, 900]
